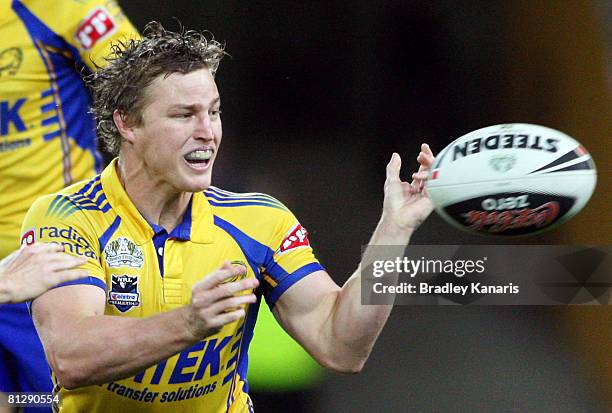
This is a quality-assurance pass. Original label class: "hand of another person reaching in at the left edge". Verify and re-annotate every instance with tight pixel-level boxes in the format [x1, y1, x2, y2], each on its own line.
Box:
[0, 243, 87, 303]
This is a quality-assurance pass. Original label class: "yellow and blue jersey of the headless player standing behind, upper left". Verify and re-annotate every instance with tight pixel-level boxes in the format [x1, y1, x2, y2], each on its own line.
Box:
[0, 0, 138, 258]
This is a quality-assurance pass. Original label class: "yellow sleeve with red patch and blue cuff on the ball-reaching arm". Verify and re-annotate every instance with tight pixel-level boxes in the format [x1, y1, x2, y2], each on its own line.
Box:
[262, 206, 324, 308]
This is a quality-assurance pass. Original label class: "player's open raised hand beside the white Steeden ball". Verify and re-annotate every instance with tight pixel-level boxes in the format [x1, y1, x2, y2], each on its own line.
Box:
[383, 143, 434, 230]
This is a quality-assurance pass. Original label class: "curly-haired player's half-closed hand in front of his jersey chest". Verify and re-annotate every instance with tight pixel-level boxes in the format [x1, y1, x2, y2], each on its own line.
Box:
[186, 262, 259, 339]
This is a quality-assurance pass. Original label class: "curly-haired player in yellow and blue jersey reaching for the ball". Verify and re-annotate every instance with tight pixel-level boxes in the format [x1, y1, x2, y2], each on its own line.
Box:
[23, 23, 433, 413]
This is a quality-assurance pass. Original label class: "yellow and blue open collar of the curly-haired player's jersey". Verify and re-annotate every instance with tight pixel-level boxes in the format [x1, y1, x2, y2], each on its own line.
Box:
[101, 158, 214, 245]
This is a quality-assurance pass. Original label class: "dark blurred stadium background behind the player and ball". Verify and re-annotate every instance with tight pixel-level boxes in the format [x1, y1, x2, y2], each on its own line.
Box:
[112, 0, 612, 412]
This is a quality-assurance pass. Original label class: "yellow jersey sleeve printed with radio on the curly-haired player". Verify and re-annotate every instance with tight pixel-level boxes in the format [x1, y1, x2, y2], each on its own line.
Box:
[21, 195, 106, 290]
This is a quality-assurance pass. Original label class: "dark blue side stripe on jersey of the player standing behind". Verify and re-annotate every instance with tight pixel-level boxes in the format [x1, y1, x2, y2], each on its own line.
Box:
[12, 0, 102, 171]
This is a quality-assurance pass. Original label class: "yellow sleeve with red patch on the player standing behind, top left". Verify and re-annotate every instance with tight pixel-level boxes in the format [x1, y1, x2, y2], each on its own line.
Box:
[29, 0, 140, 70]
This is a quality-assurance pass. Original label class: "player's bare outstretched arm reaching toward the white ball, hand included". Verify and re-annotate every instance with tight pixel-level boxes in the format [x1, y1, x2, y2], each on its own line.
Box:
[274, 144, 434, 373]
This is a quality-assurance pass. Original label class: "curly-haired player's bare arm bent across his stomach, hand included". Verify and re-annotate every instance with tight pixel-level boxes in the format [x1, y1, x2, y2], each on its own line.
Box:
[32, 263, 258, 389]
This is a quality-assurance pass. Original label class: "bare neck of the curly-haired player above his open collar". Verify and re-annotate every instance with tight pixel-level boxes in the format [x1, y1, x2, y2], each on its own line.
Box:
[117, 162, 193, 232]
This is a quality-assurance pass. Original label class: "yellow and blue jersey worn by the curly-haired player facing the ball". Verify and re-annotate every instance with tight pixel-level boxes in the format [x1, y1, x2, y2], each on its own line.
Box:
[22, 161, 322, 413]
